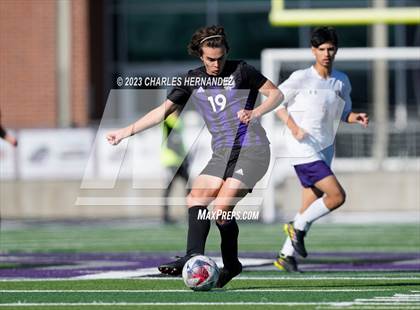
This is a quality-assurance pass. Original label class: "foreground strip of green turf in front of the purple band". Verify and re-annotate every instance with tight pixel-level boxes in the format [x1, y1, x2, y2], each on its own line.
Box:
[0, 272, 420, 309]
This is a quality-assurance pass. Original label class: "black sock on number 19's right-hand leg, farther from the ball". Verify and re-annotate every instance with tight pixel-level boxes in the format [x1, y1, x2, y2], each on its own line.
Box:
[216, 218, 239, 269]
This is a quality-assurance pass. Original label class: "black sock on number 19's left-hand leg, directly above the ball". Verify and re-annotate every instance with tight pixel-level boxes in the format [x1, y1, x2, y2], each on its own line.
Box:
[187, 206, 210, 255]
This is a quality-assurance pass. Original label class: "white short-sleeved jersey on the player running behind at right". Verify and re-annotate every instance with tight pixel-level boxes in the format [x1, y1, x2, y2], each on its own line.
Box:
[279, 66, 352, 165]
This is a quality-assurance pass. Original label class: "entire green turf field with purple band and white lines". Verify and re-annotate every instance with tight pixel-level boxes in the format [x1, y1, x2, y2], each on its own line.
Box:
[0, 224, 420, 310]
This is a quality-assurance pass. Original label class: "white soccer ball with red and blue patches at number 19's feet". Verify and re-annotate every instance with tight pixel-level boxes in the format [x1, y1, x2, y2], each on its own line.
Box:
[182, 255, 219, 291]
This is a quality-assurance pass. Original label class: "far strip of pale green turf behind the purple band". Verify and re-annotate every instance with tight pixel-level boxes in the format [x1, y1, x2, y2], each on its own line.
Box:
[0, 223, 420, 252]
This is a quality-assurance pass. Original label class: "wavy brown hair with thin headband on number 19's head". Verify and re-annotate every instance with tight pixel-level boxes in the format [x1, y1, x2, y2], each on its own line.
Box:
[188, 25, 229, 57]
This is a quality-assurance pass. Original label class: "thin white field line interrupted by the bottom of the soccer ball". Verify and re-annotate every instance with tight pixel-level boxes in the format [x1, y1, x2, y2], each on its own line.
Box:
[0, 288, 392, 293]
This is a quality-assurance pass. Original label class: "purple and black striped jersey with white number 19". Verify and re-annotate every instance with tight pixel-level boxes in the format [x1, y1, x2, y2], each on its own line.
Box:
[168, 60, 269, 150]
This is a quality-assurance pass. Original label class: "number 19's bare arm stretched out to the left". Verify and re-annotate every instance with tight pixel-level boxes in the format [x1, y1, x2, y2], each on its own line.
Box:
[106, 99, 176, 145]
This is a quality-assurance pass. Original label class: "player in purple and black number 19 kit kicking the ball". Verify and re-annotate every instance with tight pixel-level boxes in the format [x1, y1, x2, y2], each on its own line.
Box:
[107, 26, 283, 287]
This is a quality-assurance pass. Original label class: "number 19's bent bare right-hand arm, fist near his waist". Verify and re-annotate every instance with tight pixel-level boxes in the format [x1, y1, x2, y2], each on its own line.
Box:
[238, 80, 284, 124]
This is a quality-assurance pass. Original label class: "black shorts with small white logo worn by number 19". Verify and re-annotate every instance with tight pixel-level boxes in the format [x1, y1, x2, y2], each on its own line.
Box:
[200, 145, 270, 192]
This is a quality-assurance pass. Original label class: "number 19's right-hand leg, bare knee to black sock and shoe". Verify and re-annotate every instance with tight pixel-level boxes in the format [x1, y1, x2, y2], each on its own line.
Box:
[213, 178, 249, 287]
